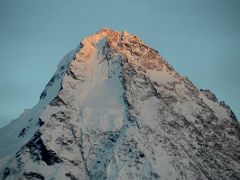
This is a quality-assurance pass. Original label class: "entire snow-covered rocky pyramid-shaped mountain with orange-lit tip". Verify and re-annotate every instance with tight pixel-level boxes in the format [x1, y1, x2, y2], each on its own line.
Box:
[0, 29, 240, 180]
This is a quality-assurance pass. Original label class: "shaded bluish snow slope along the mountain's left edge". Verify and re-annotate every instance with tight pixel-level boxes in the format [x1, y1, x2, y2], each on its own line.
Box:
[0, 48, 79, 162]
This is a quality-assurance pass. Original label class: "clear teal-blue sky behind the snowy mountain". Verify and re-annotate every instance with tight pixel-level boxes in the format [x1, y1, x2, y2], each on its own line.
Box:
[0, 0, 240, 127]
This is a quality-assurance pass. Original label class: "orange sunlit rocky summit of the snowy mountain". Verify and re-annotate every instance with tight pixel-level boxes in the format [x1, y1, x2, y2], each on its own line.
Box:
[81, 28, 171, 72]
